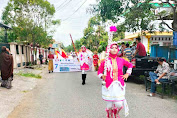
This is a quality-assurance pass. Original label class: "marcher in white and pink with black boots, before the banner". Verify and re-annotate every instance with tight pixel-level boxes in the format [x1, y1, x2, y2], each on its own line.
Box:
[78, 45, 90, 85]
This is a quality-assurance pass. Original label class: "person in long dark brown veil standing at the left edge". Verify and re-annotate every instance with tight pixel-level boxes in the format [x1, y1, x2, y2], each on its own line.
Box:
[0, 46, 13, 89]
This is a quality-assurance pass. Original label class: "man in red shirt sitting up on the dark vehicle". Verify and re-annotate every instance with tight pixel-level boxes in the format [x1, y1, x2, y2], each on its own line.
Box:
[134, 38, 146, 58]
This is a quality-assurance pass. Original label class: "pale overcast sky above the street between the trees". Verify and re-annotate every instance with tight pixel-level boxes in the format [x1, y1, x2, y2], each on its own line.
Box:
[0, 0, 96, 46]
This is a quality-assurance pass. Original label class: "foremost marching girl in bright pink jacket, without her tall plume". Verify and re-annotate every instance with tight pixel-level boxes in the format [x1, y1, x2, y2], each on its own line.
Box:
[98, 43, 133, 118]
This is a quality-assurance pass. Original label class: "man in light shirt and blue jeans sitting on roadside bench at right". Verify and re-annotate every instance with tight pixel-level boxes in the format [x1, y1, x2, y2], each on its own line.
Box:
[148, 58, 170, 97]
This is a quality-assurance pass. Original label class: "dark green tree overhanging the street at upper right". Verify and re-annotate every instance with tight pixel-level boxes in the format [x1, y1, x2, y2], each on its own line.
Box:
[92, 0, 177, 32]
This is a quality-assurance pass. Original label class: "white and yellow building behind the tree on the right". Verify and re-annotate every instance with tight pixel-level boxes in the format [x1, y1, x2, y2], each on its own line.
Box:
[122, 0, 174, 52]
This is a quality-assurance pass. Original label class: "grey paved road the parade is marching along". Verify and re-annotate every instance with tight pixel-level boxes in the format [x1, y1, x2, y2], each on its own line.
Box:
[8, 72, 177, 118]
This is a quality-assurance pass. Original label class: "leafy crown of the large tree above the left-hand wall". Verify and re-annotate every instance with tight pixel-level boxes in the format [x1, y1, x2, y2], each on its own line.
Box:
[2, 0, 60, 47]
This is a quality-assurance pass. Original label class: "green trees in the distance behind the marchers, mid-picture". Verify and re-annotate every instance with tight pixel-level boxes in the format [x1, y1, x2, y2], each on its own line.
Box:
[65, 16, 108, 52]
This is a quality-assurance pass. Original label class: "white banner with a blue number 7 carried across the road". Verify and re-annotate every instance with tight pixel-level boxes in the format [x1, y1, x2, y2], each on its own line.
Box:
[53, 59, 81, 72]
